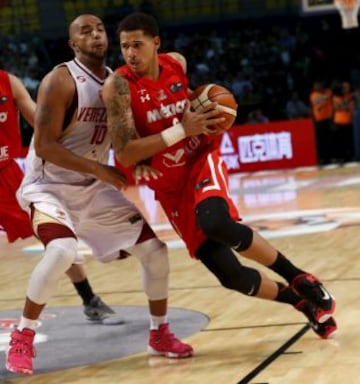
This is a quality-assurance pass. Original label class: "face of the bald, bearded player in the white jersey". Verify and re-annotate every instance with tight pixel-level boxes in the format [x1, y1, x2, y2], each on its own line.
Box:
[70, 15, 108, 59]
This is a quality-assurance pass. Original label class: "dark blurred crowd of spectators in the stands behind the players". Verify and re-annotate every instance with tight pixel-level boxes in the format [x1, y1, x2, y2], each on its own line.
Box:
[0, 11, 360, 159]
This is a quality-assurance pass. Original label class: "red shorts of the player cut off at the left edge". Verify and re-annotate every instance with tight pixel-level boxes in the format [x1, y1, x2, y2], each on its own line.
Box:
[0, 160, 33, 243]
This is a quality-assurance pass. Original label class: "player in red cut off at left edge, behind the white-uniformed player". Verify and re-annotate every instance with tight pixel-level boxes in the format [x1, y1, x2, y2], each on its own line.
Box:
[0, 70, 116, 324]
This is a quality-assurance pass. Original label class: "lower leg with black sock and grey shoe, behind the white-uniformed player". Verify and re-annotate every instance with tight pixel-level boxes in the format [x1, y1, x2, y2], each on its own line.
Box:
[66, 264, 114, 324]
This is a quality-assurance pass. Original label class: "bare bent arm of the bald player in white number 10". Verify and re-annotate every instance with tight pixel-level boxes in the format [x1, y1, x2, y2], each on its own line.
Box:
[34, 67, 125, 188]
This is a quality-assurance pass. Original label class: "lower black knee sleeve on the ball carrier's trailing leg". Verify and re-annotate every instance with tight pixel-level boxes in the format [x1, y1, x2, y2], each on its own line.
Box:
[196, 240, 261, 296]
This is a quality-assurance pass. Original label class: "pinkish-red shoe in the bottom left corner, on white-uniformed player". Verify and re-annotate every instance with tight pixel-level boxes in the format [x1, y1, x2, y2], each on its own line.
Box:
[6, 328, 36, 375]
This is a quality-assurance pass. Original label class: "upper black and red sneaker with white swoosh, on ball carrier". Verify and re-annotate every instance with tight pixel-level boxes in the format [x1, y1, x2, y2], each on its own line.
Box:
[291, 273, 336, 323]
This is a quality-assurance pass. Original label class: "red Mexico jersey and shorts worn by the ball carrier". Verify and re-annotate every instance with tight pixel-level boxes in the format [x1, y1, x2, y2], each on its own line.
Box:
[117, 54, 239, 257]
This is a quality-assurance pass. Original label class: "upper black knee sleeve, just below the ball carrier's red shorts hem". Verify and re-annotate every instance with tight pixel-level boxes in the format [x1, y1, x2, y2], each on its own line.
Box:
[196, 197, 253, 252]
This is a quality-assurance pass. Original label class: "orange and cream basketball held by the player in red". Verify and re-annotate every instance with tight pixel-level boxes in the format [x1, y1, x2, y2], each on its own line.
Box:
[189, 84, 237, 133]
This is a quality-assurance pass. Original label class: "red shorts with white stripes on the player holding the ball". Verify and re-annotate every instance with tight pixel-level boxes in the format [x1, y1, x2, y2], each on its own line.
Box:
[156, 152, 240, 258]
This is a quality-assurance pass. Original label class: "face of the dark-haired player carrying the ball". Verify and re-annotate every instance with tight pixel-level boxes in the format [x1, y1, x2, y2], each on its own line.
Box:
[120, 30, 160, 76]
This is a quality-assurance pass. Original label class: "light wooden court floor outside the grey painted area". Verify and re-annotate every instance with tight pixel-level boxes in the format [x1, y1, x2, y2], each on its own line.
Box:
[0, 164, 360, 384]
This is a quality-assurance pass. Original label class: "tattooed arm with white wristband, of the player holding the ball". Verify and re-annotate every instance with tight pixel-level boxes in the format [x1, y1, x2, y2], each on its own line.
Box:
[102, 72, 223, 167]
